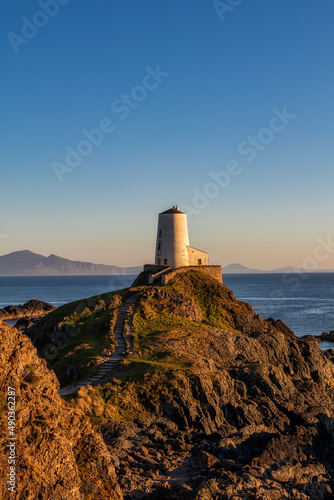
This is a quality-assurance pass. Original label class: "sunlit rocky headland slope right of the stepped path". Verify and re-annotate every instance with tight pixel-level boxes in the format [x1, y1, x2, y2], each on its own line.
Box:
[70, 274, 334, 500]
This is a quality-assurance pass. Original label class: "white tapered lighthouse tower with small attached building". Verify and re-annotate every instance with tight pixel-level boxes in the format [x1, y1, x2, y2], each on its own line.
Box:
[155, 205, 209, 269]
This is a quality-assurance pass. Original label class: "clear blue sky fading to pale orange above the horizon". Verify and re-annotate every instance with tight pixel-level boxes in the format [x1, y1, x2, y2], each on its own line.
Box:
[0, 0, 334, 269]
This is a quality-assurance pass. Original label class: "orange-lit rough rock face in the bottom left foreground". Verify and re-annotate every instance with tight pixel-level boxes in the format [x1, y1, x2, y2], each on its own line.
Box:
[0, 325, 122, 500]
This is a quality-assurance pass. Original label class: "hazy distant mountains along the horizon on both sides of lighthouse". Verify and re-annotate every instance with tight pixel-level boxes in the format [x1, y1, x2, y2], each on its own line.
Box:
[0, 250, 333, 276]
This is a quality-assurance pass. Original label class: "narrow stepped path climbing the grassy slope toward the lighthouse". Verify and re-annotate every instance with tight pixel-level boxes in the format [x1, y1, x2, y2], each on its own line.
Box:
[59, 293, 139, 396]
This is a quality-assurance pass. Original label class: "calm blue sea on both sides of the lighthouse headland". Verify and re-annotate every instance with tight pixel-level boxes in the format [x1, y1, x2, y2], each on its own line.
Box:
[0, 273, 334, 347]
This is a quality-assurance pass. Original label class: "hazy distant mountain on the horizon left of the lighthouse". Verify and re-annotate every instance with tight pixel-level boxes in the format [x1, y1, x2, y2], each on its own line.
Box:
[0, 250, 143, 276]
